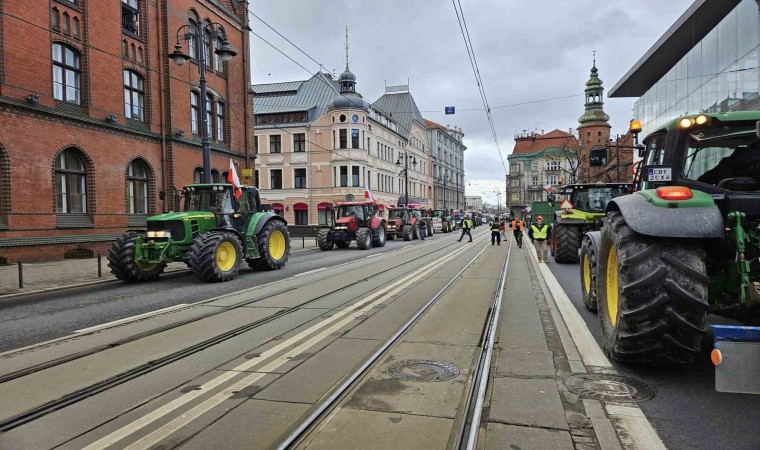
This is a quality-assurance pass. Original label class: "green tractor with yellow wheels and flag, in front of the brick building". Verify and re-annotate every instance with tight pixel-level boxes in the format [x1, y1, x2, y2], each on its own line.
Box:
[108, 183, 290, 282]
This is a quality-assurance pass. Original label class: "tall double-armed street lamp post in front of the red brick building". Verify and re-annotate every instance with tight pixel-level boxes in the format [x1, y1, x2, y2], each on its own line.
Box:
[169, 23, 237, 183]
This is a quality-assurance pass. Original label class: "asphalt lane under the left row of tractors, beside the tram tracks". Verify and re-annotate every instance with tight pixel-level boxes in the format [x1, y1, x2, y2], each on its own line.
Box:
[0, 228, 470, 352]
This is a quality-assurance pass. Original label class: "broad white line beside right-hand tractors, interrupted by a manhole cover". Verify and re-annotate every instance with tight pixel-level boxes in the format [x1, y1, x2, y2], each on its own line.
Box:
[523, 239, 667, 450]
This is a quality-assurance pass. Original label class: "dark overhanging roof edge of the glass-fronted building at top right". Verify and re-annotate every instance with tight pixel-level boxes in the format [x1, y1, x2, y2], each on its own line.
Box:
[609, 0, 741, 97]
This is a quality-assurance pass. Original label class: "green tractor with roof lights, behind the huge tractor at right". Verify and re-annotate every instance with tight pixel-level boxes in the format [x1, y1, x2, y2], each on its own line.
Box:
[548, 183, 631, 264]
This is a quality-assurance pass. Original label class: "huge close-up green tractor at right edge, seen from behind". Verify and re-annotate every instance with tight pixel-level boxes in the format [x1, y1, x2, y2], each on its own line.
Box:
[580, 111, 760, 363]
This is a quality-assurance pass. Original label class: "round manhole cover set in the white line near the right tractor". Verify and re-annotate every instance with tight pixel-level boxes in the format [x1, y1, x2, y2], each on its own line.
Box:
[565, 373, 654, 403]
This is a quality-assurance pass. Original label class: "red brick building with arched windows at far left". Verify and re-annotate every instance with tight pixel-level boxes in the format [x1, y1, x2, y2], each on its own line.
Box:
[0, 0, 252, 262]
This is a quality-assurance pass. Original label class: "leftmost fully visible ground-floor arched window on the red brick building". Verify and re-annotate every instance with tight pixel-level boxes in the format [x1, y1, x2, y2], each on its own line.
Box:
[55, 148, 87, 214]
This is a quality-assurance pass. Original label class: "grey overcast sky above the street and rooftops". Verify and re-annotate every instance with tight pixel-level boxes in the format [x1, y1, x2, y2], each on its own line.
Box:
[250, 0, 693, 203]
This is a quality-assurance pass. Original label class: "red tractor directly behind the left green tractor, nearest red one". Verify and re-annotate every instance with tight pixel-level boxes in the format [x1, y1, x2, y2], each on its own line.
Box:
[317, 202, 386, 250]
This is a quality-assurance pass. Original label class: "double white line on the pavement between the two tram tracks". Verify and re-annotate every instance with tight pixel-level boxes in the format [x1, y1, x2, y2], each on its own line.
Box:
[84, 237, 484, 450]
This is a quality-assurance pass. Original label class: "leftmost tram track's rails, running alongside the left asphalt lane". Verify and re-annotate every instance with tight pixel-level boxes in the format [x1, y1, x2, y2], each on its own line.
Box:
[0, 232, 483, 432]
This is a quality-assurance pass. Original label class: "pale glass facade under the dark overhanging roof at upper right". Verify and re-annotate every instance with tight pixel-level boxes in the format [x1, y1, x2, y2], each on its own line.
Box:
[634, 0, 760, 136]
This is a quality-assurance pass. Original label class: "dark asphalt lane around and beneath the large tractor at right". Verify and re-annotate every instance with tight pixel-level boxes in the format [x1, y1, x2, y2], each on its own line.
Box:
[549, 257, 760, 449]
